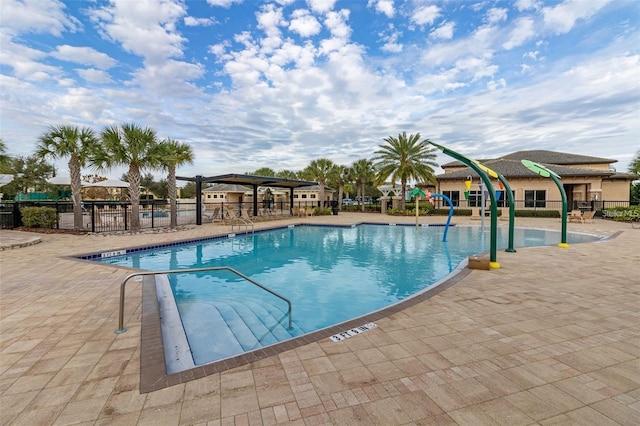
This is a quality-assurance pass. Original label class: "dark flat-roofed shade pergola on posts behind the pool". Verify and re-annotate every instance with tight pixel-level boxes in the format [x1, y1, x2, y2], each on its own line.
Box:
[176, 174, 318, 225]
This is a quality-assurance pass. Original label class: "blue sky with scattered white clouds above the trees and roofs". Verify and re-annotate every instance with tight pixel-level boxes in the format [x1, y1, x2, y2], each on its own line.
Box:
[0, 0, 640, 178]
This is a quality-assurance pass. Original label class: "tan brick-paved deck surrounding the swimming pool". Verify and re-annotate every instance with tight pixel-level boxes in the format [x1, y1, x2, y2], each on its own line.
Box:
[0, 213, 640, 426]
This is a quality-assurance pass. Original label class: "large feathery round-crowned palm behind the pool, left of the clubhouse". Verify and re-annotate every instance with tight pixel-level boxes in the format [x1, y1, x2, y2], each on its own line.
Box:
[374, 132, 438, 210]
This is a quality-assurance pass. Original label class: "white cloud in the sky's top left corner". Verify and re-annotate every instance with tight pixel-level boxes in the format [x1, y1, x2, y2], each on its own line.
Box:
[0, 0, 81, 36]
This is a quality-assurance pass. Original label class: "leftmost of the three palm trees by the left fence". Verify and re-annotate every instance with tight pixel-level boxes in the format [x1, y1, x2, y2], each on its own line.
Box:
[36, 126, 98, 231]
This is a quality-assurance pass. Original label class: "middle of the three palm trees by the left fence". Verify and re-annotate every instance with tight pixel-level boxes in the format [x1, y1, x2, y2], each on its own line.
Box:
[93, 123, 162, 233]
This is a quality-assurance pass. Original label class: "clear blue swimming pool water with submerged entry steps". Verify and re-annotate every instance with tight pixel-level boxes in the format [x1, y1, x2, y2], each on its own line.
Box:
[99, 225, 599, 365]
